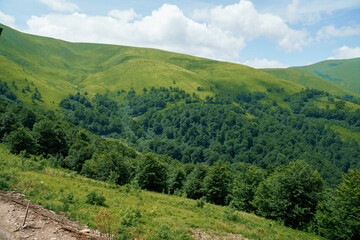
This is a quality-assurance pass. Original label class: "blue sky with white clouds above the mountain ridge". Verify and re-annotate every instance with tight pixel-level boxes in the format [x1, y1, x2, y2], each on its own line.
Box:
[0, 0, 360, 68]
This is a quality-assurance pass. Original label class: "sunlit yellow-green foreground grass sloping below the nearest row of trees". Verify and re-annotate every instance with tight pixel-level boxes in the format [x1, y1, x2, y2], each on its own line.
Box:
[0, 144, 322, 240]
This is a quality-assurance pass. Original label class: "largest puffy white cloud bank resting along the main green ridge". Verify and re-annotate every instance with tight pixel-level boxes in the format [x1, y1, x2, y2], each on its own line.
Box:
[26, 4, 245, 61]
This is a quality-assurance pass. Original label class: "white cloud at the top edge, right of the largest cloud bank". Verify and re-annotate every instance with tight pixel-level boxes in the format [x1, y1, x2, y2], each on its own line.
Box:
[194, 0, 311, 51]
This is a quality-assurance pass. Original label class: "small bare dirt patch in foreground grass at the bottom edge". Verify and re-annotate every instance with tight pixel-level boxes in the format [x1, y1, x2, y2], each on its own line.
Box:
[190, 228, 251, 240]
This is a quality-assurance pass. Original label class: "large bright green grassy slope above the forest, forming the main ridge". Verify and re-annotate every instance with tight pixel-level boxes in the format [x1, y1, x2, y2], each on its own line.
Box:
[0, 25, 302, 109]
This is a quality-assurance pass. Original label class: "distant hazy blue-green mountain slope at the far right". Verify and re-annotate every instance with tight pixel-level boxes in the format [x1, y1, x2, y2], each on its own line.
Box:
[294, 58, 360, 94]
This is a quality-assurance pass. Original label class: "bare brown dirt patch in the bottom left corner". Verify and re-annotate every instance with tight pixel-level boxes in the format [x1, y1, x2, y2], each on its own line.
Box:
[0, 191, 105, 240]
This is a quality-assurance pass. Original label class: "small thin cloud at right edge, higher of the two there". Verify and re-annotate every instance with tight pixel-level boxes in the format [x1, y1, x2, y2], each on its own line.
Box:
[316, 25, 360, 41]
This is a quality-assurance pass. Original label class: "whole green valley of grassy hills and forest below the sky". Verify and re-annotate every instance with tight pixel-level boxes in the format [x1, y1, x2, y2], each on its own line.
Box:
[0, 25, 360, 239]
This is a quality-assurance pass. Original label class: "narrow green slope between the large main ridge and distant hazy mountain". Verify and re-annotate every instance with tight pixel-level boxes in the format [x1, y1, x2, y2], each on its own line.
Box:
[262, 68, 360, 97]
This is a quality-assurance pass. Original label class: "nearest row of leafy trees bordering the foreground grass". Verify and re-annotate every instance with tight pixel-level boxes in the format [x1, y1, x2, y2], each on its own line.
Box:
[0, 88, 360, 239]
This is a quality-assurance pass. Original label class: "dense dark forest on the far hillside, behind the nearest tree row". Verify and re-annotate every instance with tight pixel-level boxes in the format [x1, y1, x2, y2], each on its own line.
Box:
[60, 88, 360, 187]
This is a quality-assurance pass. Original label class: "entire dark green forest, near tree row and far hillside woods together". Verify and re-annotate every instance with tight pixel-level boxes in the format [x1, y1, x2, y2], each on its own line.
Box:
[0, 81, 360, 239]
